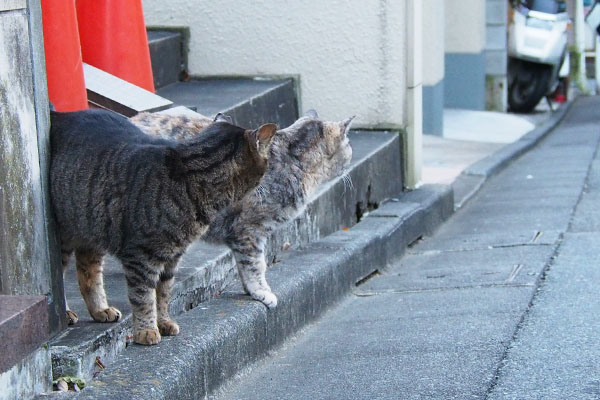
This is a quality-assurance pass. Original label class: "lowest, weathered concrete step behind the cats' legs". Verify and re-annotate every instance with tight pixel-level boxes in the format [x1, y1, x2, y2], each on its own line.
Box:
[50, 131, 404, 379]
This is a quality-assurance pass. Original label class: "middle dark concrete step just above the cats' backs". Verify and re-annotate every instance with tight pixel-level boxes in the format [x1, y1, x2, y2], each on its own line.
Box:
[157, 78, 298, 127]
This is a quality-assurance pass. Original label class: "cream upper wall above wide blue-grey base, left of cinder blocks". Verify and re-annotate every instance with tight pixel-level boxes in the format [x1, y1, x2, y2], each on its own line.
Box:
[445, 0, 486, 53]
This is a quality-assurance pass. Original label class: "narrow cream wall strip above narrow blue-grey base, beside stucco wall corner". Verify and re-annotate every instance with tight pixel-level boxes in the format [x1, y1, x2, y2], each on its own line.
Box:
[422, 0, 445, 86]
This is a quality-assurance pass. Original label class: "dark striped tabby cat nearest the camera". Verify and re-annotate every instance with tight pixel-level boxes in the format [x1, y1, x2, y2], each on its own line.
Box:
[50, 110, 276, 344]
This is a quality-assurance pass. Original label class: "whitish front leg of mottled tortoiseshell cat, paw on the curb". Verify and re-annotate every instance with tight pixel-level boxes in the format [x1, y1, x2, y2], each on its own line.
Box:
[233, 250, 277, 308]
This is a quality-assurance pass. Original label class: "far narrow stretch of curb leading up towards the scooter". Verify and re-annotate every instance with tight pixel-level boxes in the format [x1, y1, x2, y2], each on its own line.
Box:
[452, 98, 577, 210]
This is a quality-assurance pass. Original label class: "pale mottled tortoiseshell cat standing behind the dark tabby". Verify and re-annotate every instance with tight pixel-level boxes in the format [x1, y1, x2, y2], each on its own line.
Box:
[132, 111, 352, 307]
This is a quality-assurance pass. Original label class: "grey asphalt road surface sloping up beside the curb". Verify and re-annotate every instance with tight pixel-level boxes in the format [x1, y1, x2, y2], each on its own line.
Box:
[213, 97, 600, 400]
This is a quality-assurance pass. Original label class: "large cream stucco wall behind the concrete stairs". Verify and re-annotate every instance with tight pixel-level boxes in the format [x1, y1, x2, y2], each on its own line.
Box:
[143, 0, 406, 126]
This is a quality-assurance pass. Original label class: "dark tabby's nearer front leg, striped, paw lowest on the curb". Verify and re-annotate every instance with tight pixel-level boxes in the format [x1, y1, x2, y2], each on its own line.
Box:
[120, 255, 162, 345]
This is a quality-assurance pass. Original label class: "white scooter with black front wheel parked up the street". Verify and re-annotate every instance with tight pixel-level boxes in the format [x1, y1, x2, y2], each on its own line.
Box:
[508, 0, 570, 112]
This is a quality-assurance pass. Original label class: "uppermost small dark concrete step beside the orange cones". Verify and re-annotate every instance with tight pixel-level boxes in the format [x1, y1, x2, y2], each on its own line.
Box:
[148, 30, 187, 89]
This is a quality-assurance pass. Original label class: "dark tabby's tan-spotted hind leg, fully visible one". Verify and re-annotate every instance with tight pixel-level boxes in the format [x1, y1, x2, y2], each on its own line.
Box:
[75, 249, 121, 322]
